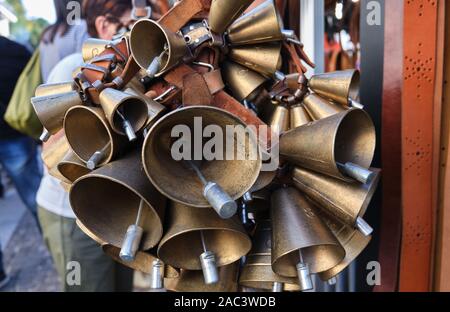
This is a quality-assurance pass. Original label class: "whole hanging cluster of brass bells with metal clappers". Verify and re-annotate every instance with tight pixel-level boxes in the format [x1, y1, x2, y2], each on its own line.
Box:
[32, 0, 380, 291]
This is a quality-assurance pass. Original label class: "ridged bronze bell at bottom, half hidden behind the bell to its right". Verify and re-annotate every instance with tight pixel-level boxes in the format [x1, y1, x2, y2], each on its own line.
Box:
[239, 220, 300, 292]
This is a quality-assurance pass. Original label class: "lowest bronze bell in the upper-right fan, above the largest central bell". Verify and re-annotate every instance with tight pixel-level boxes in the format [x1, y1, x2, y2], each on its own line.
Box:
[222, 61, 266, 102]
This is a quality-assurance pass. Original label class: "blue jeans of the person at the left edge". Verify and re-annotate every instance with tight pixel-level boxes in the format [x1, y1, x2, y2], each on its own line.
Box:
[0, 137, 42, 220]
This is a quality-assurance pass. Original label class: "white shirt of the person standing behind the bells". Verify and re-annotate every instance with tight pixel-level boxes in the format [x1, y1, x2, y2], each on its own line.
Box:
[36, 53, 83, 219]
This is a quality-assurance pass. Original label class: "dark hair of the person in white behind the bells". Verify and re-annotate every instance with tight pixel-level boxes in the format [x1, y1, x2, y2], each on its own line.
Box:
[82, 0, 133, 38]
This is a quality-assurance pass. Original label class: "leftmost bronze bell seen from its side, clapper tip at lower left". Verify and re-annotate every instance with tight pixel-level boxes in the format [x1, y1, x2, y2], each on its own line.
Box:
[31, 84, 83, 142]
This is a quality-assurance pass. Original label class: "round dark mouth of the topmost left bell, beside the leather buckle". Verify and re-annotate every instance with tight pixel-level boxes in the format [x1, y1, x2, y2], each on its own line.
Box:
[130, 20, 172, 74]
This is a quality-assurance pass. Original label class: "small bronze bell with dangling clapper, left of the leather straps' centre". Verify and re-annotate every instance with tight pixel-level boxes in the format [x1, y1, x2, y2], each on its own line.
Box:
[100, 88, 149, 141]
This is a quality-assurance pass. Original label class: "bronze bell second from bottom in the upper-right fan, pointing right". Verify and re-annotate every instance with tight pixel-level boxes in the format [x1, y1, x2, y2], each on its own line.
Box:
[229, 42, 283, 77]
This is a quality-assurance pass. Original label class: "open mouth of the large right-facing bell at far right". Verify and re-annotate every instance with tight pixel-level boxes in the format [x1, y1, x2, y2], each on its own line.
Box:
[333, 109, 376, 173]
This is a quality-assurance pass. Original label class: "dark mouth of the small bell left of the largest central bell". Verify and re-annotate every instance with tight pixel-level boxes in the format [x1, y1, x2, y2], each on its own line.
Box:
[112, 97, 148, 135]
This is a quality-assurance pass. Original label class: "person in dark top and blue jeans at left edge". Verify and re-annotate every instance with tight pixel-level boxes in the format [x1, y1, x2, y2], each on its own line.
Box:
[0, 36, 41, 289]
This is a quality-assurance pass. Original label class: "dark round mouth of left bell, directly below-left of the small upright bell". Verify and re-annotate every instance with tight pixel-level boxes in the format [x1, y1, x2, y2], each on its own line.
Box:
[64, 106, 114, 167]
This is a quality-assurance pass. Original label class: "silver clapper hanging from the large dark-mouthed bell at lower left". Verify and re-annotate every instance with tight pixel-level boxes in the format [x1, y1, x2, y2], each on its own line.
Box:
[119, 199, 145, 262]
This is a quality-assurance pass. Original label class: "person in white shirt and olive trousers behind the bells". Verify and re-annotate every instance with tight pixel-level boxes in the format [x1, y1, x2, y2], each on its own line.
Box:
[37, 0, 133, 292]
